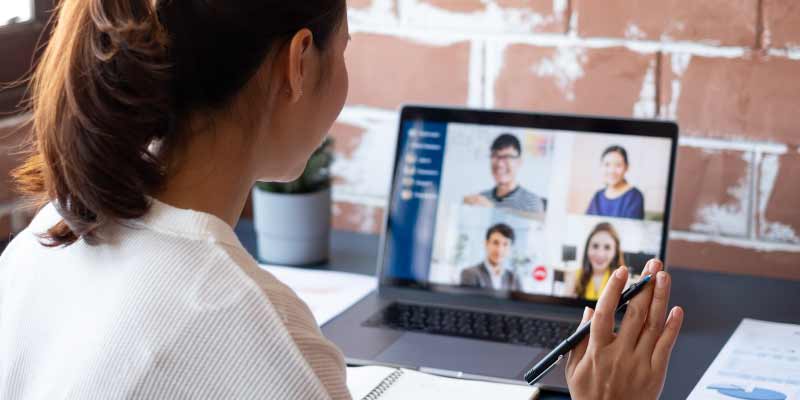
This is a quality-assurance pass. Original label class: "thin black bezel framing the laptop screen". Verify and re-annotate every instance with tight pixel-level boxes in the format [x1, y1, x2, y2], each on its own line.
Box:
[376, 105, 678, 307]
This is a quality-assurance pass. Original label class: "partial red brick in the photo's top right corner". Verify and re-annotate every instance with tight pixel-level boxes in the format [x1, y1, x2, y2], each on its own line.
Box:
[763, 0, 800, 48]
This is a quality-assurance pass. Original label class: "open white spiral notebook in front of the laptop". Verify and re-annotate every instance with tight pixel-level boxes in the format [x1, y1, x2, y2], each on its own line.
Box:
[347, 366, 539, 400]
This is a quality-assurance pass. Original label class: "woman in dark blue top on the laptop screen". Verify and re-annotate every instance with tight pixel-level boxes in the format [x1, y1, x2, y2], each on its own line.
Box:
[586, 146, 644, 219]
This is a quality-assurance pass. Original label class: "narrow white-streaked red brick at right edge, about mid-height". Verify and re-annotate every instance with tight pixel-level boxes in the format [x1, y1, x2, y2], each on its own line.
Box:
[758, 152, 800, 242]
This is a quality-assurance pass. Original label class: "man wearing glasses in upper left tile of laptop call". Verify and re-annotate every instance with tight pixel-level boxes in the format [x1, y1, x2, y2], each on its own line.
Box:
[464, 133, 547, 213]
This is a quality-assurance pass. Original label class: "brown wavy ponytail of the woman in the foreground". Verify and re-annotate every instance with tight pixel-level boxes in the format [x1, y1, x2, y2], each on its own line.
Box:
[14, 0, 171, 246]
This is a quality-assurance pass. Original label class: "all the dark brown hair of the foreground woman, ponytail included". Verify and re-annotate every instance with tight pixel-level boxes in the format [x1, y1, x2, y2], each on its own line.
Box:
[14, 0, 346, 246]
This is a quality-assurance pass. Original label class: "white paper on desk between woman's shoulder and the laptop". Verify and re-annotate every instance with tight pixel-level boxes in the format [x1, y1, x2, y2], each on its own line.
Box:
[261, 265, 377, 326]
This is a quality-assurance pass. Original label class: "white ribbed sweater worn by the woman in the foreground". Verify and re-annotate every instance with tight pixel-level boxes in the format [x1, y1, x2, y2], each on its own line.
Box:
[0, 201, 350, 400]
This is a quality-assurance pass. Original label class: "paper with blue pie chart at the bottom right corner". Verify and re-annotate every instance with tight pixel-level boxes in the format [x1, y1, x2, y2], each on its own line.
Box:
[688, 319, 800, 400]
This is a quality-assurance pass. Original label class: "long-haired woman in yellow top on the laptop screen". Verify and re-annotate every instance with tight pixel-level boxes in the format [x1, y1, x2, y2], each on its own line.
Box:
[567, 222, 625, 301]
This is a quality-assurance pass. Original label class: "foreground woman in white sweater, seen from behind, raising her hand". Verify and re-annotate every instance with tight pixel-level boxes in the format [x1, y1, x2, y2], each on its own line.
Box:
[0, 0, 677, 399]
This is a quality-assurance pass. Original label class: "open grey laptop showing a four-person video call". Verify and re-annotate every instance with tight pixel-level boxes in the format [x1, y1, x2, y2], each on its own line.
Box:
[322, 106, 678, 390]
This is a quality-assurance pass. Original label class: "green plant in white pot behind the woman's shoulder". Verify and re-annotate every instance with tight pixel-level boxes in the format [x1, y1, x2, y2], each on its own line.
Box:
[253, 138, 333, 266]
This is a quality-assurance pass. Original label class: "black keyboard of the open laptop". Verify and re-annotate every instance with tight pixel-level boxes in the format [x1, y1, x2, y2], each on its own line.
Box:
[363, 303, 578, 348]
